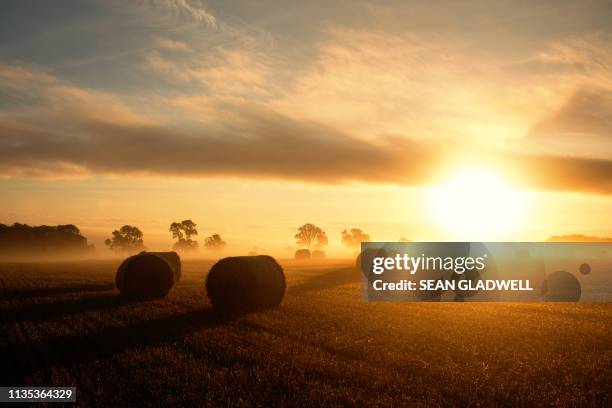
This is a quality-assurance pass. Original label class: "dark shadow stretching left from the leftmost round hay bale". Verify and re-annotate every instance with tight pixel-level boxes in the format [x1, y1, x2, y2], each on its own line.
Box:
[0, 294, 136, 323]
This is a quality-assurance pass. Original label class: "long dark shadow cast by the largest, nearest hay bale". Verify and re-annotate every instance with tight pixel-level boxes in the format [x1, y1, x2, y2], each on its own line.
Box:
[0, 308, 228, 385]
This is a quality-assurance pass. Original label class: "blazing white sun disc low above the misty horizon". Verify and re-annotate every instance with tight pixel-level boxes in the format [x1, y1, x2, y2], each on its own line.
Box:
[430, 169, 528, 241]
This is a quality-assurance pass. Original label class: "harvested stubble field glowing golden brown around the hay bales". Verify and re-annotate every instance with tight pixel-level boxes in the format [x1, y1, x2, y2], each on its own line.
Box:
[0, 260, 612, 406]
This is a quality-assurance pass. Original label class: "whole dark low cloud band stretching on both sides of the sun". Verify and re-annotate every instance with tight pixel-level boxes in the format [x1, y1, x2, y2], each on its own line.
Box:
[0, 99, 612, 194]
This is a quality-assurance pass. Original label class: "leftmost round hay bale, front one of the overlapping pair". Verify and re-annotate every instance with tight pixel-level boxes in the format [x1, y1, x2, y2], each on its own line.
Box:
[115, 253, 174, 299]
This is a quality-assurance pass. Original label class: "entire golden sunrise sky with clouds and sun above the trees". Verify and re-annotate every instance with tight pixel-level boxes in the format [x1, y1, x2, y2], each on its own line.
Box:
[0, 0, 612, 254]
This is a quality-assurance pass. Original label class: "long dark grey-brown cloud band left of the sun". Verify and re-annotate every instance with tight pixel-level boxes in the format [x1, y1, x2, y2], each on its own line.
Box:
[0, 110, 436, 184]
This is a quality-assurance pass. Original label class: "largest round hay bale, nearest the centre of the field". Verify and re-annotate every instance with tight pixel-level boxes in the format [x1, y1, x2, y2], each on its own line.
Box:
[206, 255, 286, 310]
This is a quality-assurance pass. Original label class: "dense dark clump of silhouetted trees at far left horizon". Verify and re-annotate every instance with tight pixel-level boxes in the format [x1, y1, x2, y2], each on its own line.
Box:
[0, 223, 93, 255]
